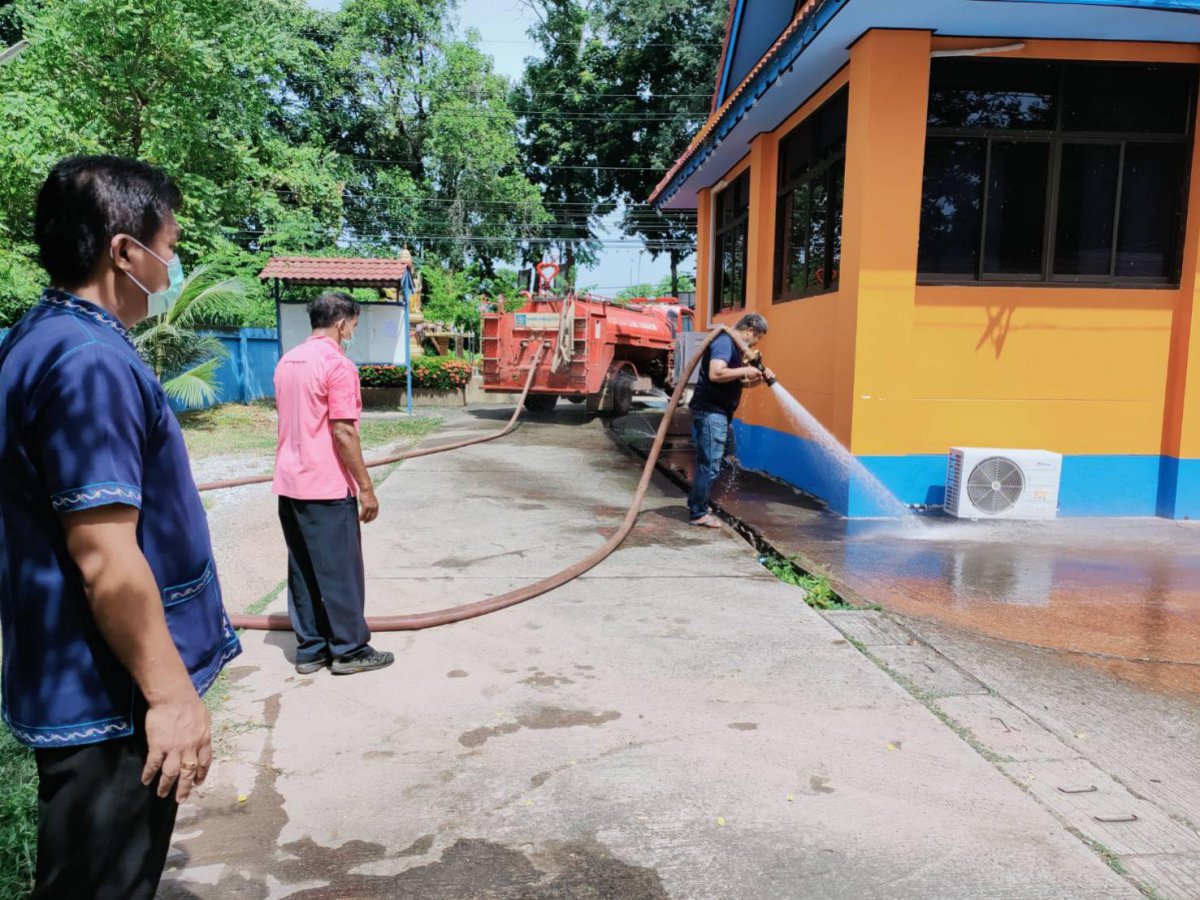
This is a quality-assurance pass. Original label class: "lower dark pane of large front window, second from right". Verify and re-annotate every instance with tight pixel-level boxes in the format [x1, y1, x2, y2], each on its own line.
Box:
[1054, 144, 1121, 275]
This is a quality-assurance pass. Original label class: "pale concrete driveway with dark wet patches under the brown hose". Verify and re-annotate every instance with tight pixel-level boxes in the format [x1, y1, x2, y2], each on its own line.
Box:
[162, 410, 1153, 900]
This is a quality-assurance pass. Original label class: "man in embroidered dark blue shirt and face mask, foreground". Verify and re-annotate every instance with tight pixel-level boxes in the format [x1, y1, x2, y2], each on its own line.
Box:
[0, 157, 240, 900]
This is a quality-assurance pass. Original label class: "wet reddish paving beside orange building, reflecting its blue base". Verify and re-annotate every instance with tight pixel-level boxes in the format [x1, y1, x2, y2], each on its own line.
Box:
[616, 413, 1200, 696]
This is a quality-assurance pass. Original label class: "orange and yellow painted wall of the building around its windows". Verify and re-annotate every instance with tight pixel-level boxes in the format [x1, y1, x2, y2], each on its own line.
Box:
[700, 31, 1200, 513]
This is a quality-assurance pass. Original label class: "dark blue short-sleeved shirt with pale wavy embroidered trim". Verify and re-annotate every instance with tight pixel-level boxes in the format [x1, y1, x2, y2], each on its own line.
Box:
[0, 289, 241, 748]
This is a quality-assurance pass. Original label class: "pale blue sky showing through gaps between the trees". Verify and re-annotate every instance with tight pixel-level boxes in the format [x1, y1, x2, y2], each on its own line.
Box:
[308, 0, 696, 295]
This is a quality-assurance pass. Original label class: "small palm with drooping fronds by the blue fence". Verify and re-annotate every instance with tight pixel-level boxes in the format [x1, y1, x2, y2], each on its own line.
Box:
[133, 265, 248, 408]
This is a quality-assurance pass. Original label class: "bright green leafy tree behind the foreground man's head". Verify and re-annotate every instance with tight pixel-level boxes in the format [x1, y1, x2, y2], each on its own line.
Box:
[0, 0, 342, 314]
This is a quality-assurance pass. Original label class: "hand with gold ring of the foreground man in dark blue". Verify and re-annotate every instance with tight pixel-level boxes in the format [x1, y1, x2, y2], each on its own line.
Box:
[142, 690, 212, 803]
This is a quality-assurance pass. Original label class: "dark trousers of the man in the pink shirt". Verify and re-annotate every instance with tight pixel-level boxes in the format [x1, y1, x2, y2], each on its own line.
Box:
[280, 497, 371, 662]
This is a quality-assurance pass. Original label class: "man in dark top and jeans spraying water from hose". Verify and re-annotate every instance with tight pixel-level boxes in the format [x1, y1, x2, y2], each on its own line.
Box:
[688, 313, 774, 528]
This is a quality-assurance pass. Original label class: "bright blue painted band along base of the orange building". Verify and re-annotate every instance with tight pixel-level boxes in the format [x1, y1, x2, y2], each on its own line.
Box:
[734, 421, 1200, 518]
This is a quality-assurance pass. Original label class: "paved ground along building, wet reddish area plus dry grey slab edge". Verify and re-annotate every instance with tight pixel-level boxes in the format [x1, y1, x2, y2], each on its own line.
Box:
[614, 413, 1200, 898]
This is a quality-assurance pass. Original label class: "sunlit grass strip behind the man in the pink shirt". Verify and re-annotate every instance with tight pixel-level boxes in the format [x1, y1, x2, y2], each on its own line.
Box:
[179, 401, 442, 460]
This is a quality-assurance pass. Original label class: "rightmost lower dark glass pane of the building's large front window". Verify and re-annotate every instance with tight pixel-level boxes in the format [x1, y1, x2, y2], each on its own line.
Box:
[1116, 144, 1187, 278]
